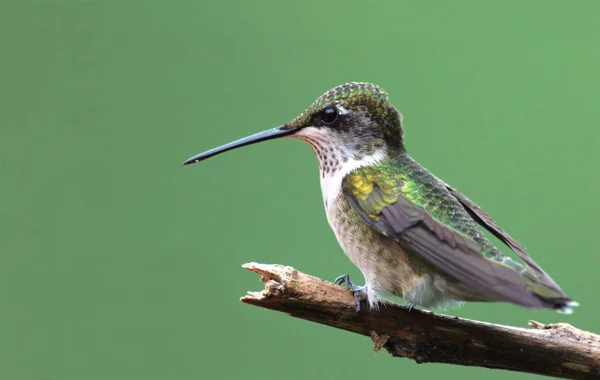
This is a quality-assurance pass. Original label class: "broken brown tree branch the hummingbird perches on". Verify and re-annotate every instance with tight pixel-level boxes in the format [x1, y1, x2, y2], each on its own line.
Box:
[241, 263, 600, 379]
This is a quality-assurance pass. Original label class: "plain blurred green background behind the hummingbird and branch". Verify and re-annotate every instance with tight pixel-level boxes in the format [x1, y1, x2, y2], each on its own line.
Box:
[0, 0, 600, 380]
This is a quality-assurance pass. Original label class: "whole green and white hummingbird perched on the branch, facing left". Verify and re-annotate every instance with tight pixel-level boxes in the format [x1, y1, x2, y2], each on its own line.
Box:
[183, 82, 578, 314]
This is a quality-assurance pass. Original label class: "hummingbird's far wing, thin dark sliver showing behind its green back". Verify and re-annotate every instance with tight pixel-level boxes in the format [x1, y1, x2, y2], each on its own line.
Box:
[445, 184, 560, 291]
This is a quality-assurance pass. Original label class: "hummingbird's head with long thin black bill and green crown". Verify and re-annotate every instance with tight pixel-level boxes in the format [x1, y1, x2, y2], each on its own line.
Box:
[183, 82, 404, 175]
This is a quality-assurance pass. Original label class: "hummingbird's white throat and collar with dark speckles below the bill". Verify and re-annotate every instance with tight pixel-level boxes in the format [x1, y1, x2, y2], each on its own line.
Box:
[294, 127, 388, 210]
